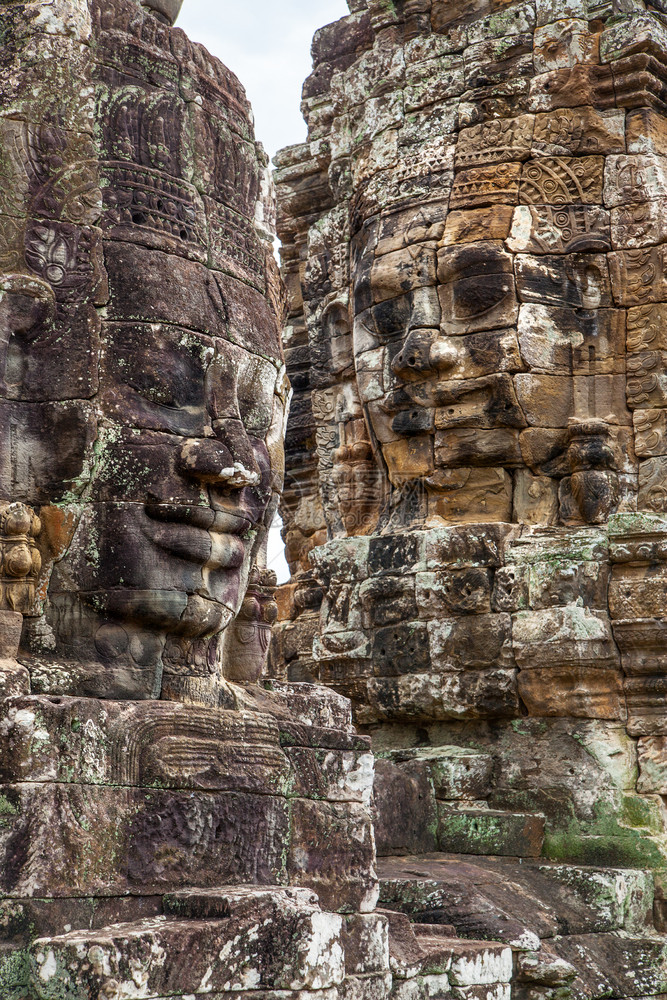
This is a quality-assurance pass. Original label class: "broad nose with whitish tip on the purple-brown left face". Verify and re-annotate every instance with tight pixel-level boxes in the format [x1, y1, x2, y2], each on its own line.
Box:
[179, 420, 261, 489]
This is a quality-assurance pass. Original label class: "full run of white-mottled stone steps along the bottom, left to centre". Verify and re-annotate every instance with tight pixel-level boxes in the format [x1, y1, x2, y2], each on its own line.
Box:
[0, 886, 513, 1000]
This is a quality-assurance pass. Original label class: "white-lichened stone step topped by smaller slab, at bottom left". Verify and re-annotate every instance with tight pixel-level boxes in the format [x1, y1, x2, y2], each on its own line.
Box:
[30, 887, 345, 1000]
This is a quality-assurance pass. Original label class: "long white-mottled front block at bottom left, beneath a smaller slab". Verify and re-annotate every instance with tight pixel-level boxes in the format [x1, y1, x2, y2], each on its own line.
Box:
[31, 893, 345, 998]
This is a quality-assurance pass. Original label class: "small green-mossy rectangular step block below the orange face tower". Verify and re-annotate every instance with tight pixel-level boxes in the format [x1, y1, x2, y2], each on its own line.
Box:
[438, 805, 545, 858]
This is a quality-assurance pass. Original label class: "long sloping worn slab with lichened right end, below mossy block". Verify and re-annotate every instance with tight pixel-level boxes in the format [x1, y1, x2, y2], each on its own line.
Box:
[377, 854, 654, 951]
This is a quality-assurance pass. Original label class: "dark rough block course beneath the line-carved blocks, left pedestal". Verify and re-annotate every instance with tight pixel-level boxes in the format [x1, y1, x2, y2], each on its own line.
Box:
[0, 784, 290, 897]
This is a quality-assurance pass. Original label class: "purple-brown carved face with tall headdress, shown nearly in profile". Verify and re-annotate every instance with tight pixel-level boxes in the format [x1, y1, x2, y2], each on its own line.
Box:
[0, 0, 286, 696]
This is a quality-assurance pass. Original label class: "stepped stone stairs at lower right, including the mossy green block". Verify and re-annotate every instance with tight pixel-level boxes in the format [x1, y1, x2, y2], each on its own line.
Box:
[375, 746, 667, 1000]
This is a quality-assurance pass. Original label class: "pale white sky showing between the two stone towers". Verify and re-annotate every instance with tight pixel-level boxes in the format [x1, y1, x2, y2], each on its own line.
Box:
[177, 0, 349, 582]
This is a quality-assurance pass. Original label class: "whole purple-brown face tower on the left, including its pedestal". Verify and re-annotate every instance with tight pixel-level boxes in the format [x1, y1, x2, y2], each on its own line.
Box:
[0, 0, 392, 1000]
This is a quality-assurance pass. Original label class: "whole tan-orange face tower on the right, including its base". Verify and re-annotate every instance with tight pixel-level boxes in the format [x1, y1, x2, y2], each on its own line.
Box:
[271, 0, 667, 1000]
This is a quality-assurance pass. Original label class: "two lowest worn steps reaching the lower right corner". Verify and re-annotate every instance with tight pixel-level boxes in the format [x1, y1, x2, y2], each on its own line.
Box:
[378, 853, 667, 1000]
